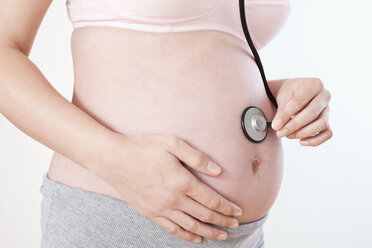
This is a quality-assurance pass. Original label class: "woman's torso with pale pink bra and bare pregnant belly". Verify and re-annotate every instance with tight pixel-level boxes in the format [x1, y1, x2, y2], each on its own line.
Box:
[48, 0, 289, 223]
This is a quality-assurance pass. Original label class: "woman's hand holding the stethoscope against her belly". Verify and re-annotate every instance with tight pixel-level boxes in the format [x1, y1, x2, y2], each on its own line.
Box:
[272, 78, 332, 146]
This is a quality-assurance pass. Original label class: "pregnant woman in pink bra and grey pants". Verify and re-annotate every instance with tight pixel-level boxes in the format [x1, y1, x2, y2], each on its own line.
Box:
[0, 0, 332, 248]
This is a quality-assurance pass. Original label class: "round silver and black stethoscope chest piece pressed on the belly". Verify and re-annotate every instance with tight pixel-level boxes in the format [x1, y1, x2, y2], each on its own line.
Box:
[241, 106, 271, 143]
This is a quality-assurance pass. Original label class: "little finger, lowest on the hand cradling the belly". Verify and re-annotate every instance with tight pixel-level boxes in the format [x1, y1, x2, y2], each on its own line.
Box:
[152, 216, 201, 243]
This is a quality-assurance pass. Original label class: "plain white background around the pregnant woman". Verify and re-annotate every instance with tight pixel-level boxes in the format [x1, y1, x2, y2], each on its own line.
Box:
[0, 0, 372, 248]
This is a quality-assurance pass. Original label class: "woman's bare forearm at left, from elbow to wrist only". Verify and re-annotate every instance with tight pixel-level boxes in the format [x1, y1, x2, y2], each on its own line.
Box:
[0, 47, 124, 177]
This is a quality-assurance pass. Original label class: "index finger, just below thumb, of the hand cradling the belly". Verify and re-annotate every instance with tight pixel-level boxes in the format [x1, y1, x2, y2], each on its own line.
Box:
[185, 177, 243, 216]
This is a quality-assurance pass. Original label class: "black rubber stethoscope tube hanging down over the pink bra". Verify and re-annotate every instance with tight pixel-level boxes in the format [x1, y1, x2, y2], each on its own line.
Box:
[239, 0, 278, 109]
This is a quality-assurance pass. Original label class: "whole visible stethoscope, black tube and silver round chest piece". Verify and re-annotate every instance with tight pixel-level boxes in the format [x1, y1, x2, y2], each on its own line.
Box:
[239, 0, 278, 143]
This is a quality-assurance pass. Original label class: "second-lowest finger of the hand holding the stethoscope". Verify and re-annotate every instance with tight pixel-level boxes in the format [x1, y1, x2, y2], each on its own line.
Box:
[287, 106, 329, 139]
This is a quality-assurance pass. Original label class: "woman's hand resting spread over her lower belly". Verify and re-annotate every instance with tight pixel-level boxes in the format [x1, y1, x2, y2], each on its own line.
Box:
[100, 134, 241, 242]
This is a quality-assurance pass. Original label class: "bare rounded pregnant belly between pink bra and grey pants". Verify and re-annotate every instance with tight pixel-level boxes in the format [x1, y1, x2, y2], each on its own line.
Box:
[48, 27, 283, 223]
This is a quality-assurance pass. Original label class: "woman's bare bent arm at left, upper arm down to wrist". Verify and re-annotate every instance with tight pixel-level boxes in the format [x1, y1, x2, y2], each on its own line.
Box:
[0, 0, 122, 178]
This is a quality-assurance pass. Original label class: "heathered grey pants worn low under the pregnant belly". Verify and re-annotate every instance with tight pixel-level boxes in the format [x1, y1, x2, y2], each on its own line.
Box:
[40, 174, 267, 248]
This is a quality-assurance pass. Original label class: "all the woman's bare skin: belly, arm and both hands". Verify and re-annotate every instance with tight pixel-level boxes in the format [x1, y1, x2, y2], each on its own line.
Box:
[0, 0, 331, 242]
